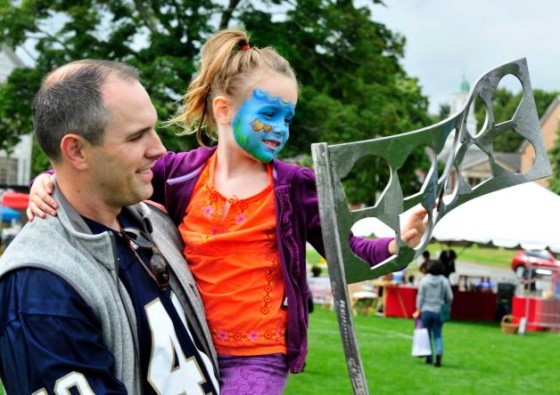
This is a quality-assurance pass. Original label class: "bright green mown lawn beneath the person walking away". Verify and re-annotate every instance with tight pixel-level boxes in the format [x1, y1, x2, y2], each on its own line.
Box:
[285, 306, 560, 395]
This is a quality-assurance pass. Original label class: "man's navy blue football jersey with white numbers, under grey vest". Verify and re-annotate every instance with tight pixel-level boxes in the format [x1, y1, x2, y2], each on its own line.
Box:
[0, 213, 218, 395]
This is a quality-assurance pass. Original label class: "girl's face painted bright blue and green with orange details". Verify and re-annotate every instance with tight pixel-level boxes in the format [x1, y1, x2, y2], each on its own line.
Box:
[233, 89, 296, 162]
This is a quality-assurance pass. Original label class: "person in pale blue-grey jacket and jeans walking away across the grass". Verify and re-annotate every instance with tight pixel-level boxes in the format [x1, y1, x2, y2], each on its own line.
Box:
[412, 260, 453, 367]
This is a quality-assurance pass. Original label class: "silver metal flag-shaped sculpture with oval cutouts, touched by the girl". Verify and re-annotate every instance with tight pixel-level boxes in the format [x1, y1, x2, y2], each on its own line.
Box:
[312, 59, 551, 394]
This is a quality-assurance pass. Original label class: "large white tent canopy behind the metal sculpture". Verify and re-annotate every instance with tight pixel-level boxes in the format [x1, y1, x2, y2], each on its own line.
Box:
[352, 182, 560, 252]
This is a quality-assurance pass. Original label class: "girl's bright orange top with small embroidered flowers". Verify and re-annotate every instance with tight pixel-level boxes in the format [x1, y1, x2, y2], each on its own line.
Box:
[179, 154, 287, 355]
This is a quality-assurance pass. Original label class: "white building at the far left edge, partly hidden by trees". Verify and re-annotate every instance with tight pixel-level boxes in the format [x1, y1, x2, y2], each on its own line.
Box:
[0, 44, 32, 186]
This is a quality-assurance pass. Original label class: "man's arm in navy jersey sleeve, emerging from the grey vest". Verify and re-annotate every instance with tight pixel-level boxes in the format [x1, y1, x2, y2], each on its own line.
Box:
[0, 269, 126, 394]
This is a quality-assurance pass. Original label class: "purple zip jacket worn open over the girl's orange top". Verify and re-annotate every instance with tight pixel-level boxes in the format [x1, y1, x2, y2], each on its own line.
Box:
[152, 147, 391, 373]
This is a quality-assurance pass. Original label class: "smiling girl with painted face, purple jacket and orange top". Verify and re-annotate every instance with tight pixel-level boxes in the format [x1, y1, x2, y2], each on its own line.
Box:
[28, 30, 426, 395]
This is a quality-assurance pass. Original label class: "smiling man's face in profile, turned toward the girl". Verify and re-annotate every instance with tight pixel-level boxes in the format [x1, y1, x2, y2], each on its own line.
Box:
[90, 78, 165, 208]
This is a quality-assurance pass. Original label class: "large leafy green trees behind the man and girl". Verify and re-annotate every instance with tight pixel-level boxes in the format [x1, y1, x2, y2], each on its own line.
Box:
[0, 0, 431, 203]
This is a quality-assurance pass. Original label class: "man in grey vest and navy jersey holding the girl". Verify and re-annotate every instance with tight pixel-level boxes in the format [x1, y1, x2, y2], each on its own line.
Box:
[0, 60, 218, 395]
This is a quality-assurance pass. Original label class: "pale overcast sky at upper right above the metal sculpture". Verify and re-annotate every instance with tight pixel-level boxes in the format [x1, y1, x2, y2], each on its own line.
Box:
[368, 0, 560, 115]
